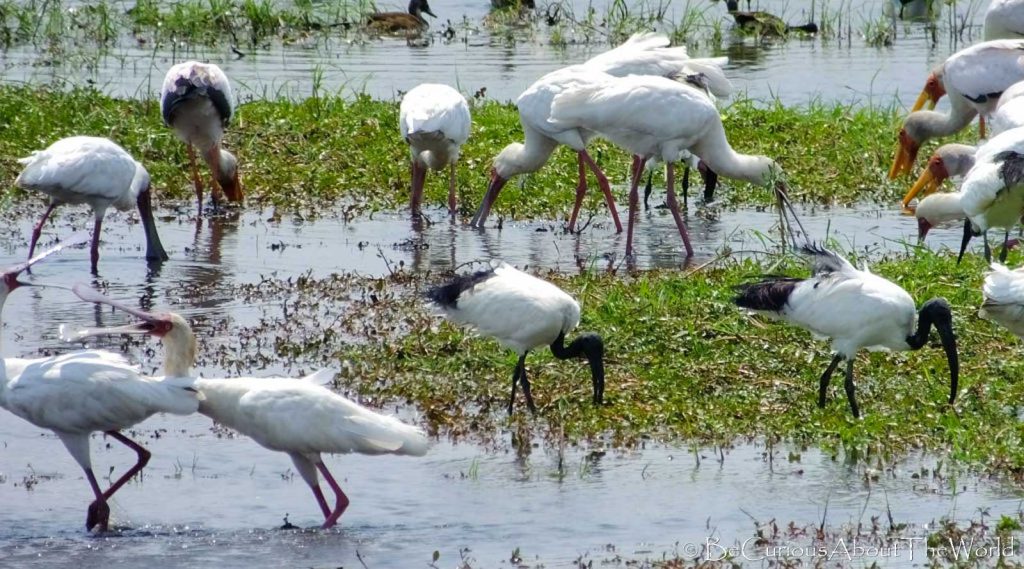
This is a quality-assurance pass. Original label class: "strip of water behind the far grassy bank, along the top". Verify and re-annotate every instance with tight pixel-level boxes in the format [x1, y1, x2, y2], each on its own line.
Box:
[0, 0, 988, 105]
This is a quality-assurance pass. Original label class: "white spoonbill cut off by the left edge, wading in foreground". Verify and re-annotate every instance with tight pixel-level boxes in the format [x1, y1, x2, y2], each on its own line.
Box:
[0, 237, 200, 531]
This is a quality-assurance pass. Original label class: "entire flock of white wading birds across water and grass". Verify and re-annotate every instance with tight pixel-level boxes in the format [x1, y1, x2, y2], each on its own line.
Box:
[6, 0, 1024, 530]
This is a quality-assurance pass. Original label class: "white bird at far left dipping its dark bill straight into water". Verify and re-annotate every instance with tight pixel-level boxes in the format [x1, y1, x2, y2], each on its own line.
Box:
[14, 136, 167, 272]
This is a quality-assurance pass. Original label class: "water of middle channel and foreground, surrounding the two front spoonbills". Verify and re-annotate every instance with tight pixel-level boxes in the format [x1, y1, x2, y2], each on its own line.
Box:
[0, 208, 1007, 569]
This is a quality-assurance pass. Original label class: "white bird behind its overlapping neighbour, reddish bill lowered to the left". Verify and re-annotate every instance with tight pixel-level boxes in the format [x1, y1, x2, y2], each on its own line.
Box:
[470, 34, 732, 231]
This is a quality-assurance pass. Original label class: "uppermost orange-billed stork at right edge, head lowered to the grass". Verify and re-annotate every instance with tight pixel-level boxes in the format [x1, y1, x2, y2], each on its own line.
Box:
[889, 40, 1024, 179]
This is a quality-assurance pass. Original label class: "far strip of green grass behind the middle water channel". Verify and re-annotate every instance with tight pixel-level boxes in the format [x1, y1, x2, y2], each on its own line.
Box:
[0, 86, 929, 219]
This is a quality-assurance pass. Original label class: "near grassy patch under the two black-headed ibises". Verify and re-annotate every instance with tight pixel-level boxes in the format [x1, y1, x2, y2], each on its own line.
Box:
[223, 251, 1024, 479]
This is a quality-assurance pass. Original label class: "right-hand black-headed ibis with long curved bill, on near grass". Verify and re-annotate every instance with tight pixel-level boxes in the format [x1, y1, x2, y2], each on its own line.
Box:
[734, 245, 959, 418]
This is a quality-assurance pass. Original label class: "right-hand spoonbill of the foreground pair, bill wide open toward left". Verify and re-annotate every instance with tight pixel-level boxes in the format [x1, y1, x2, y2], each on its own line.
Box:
[71, 285, 428, 529]
